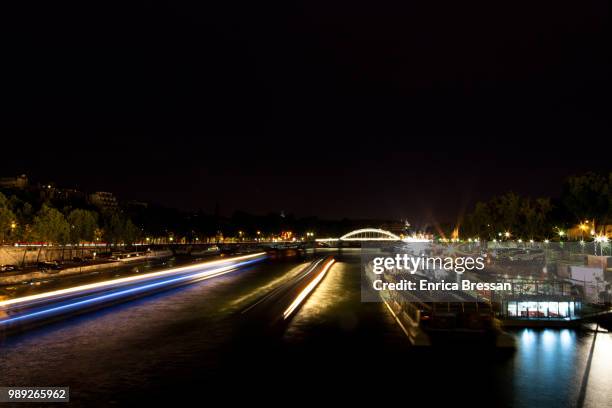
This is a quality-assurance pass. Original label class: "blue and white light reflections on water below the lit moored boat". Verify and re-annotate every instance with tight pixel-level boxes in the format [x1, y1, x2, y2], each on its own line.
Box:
[490, 329, 612, 407]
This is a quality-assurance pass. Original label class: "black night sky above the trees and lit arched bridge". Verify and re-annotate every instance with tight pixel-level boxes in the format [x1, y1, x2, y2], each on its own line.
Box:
[0, 0, 612, 223]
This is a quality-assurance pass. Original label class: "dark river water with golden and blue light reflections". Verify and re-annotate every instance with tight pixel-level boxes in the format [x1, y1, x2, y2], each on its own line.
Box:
[0, 250, 612, 408]
